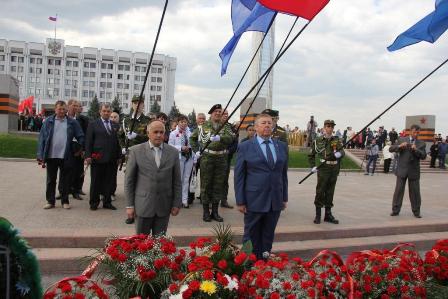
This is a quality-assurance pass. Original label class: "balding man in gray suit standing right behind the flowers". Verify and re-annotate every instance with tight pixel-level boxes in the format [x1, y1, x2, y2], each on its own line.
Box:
[124, 120, 182, 235]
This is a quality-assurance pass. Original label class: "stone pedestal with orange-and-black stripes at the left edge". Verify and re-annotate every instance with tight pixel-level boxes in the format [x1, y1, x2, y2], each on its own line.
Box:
[0, 75, 19, 133]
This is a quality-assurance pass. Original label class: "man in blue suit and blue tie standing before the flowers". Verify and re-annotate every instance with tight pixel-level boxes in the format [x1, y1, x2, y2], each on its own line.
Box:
[234, 114, 288, 259]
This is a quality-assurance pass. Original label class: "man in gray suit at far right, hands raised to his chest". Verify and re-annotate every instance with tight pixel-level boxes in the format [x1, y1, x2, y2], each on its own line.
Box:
[389, 125, 426, 218]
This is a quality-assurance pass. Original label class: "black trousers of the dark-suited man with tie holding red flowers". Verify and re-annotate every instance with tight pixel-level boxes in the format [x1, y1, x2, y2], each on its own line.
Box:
[89, 161, 116, 207]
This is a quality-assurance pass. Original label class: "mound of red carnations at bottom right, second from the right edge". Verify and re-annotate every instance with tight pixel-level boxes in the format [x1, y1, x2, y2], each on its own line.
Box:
[347, 244, 426, 299]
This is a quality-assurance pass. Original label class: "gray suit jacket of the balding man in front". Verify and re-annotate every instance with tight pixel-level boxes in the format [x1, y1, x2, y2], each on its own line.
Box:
[124, 142, 182, 218]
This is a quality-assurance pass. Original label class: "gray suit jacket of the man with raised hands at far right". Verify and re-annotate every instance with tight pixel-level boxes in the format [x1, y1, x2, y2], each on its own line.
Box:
[389, 137, 426, 180]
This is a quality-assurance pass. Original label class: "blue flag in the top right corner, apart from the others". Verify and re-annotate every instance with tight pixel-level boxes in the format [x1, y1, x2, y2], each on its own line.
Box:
[387, 0, 448, 52]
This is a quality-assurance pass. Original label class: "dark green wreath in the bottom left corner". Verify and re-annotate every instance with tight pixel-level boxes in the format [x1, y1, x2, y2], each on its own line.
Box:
[0, 217, 43, 299]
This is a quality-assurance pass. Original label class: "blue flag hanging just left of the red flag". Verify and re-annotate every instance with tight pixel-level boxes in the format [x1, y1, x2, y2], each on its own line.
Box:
[219, 0, 276, 76]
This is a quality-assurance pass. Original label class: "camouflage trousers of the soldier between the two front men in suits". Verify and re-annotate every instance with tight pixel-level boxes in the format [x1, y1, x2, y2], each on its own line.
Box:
[200, 153, 228, 204]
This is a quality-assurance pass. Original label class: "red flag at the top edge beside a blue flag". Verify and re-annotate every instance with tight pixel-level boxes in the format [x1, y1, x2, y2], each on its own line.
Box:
[258, 0, 330, 21]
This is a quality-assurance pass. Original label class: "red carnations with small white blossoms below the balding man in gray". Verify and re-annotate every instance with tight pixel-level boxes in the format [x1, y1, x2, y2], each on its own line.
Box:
[95, 235, 186, 298]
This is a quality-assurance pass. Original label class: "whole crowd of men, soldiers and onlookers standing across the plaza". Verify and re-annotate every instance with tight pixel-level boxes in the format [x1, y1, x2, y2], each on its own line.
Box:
[37, 99, 447, 258]
